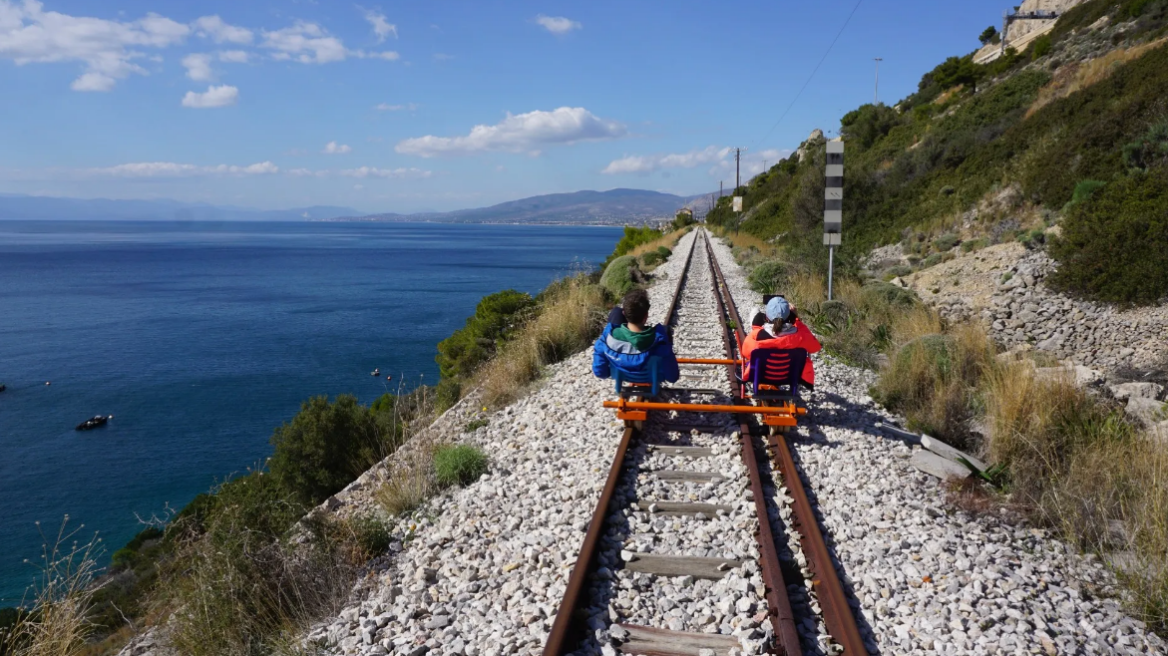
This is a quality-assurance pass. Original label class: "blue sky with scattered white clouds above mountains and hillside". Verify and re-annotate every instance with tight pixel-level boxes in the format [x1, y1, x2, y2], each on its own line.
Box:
[0, 0, 1009, 212]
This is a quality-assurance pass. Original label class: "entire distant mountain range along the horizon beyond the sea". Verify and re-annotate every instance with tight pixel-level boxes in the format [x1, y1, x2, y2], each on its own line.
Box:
[0, 189, 710, 225]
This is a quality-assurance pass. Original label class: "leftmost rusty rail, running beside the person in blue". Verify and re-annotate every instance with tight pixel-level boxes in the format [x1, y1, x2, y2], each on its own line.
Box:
[543, 228, 698, 656]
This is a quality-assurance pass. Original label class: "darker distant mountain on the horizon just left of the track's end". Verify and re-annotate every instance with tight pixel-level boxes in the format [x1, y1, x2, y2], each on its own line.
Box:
[341, 189, 707, 225]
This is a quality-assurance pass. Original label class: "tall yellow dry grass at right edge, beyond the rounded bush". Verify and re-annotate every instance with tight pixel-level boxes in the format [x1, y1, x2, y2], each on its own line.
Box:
[986, 362, 1168, 634]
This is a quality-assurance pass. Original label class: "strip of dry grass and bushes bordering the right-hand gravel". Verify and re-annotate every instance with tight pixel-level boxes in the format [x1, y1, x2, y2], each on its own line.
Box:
[872, 317, 1168, 635]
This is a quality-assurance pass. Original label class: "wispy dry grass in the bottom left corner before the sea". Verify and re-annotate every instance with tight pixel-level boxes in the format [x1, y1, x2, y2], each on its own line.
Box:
[0, 516, 102, 656]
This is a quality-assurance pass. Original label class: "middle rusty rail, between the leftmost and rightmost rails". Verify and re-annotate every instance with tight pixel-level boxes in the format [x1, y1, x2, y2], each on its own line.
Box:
[704, 231, 802, 656]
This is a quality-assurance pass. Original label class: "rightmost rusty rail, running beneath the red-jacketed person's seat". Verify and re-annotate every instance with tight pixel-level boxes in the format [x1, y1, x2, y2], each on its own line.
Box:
[707, 229, 868, 656]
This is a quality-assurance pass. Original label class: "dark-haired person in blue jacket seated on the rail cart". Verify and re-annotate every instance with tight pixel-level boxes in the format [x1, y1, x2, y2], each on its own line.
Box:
[592, 289, 681, 383]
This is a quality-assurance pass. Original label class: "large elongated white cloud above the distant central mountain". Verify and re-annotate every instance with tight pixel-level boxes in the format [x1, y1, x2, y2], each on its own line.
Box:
[394, 107, 627, 158]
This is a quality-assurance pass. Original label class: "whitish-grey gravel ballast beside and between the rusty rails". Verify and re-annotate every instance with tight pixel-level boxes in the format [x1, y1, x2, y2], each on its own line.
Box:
[289, 229, 1168, 656]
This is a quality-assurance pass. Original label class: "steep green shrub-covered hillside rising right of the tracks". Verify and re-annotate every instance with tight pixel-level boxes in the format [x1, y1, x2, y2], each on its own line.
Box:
[708, 0, 1168, 303]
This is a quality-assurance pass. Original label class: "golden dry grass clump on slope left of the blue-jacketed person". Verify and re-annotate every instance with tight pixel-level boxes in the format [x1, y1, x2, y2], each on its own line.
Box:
[478, 270, 609, 406]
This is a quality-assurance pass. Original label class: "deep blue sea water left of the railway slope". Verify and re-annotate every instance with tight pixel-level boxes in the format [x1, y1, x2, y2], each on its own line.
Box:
[0, 221, 620, 606]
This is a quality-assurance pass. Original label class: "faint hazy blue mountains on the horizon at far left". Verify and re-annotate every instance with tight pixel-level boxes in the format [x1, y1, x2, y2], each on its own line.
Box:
[0, 194, 360, 221]
